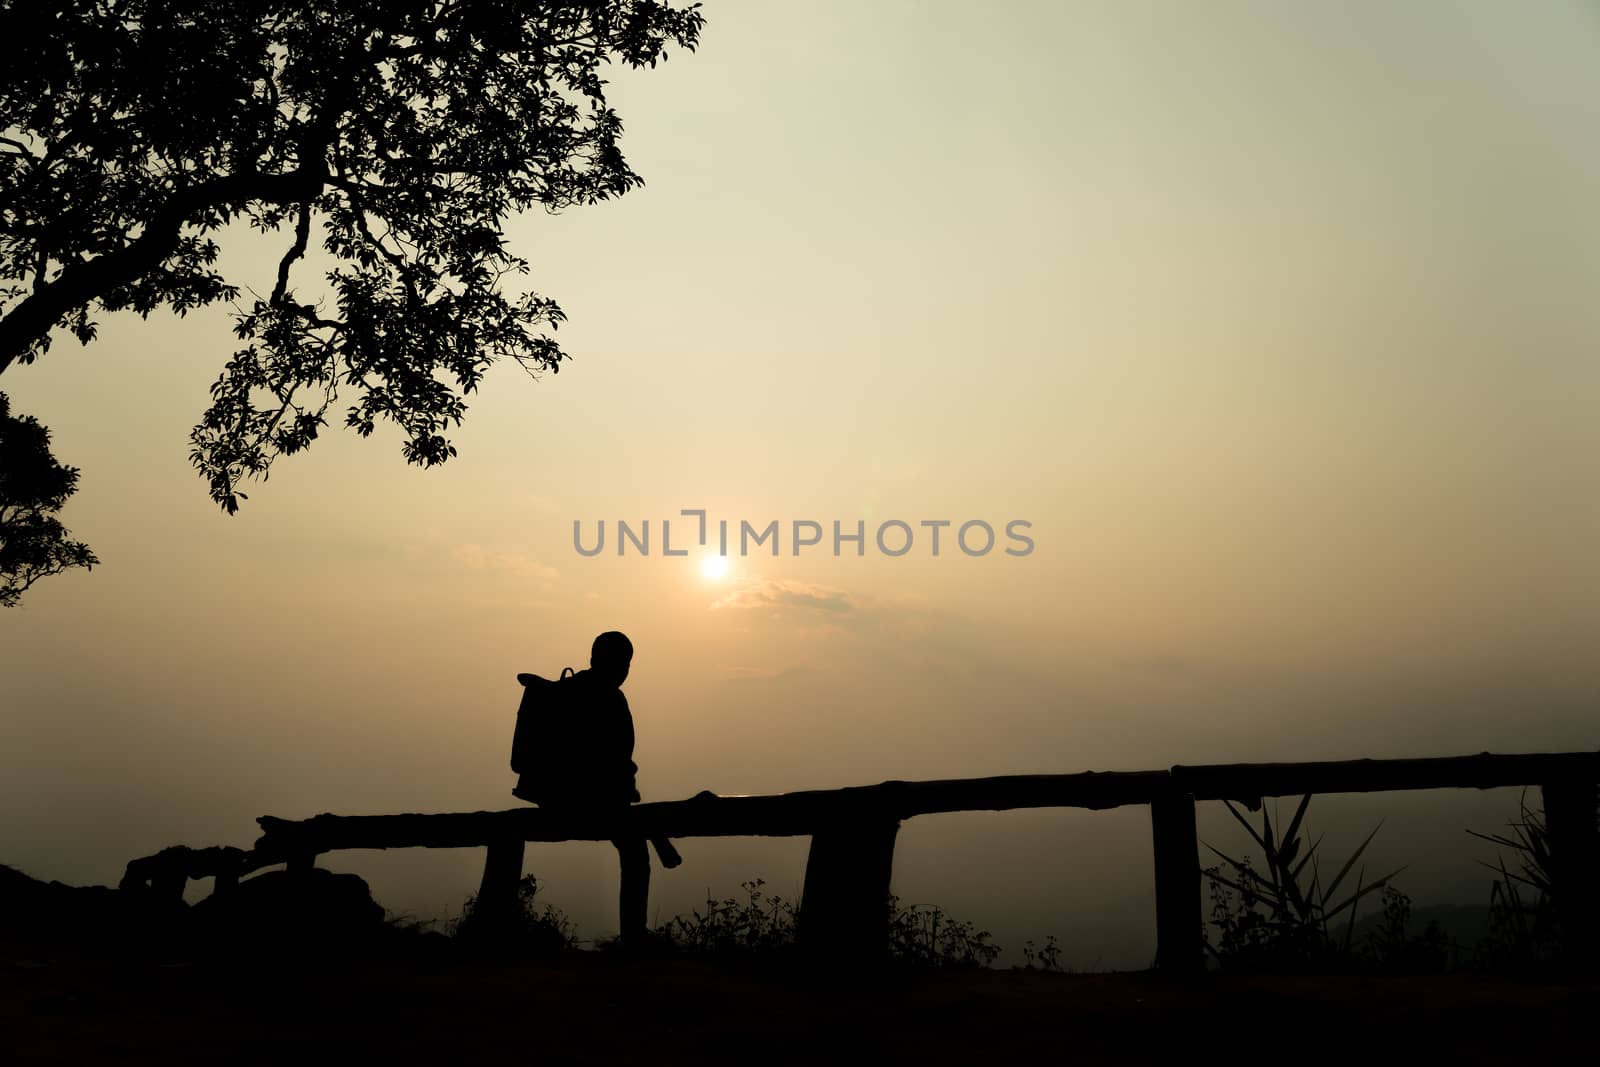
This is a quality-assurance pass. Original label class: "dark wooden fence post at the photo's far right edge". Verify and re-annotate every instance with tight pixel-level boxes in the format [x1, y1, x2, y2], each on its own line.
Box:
[1539, 777, 1600, 966]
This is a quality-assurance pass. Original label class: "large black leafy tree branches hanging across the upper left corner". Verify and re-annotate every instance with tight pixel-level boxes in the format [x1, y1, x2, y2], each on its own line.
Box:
[0, 0, 702, 575]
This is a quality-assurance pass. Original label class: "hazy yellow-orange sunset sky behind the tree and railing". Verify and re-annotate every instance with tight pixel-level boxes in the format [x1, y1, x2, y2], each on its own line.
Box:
[0, 0, 1600, 966]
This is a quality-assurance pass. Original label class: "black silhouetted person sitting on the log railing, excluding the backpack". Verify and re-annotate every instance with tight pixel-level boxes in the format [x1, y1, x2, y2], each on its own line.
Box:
[514, 630, 678, 942]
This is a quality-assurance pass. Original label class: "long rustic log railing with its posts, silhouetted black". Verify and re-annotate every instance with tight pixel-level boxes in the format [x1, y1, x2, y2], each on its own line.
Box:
[123, 752, 1600, 971]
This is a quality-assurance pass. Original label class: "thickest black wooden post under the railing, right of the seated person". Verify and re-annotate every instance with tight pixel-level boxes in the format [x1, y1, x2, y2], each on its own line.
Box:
[797, 814, 899, 960]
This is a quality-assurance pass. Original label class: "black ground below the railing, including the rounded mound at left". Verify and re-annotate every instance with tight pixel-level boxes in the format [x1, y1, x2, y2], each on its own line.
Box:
[0, 867, 1600, 1067]
